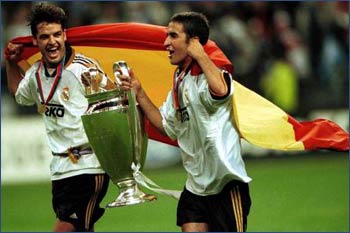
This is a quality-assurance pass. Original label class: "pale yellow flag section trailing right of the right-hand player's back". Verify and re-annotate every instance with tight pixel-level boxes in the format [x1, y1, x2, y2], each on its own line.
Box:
[233, 82, 304, 150]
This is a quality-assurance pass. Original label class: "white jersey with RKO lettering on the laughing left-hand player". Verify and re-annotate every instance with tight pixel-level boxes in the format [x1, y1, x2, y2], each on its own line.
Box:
[15, 47, 104, 180]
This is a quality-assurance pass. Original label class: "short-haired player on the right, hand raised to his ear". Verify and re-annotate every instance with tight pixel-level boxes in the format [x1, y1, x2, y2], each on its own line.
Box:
[118, 12, 251, 232]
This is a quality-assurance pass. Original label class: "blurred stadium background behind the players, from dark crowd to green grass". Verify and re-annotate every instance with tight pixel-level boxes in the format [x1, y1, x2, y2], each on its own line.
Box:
[1, 1, 349, 232]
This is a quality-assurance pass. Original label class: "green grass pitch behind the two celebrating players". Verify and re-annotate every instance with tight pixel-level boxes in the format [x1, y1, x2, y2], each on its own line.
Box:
[1, 152, 349, 232]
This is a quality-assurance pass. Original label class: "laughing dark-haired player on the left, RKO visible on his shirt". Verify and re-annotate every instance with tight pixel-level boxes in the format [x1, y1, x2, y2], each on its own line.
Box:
[5, 3, 114, 232]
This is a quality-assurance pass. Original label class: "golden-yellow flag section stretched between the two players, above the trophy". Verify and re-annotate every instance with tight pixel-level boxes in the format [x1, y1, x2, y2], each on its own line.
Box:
[28, 46, 175, 107]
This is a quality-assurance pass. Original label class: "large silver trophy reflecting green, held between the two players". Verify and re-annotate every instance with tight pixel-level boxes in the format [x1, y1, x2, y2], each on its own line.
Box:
[82, 61, 156, 207]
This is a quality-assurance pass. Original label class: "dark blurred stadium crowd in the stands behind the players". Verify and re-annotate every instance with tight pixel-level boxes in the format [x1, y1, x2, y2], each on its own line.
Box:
[1, 1, 349, 117]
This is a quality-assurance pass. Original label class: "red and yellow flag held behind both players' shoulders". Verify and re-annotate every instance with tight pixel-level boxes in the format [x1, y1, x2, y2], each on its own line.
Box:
[11, 23, 349, 151]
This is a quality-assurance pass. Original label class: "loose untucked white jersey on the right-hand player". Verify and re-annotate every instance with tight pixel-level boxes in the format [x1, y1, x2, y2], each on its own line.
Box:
[160, 68, 251, 196]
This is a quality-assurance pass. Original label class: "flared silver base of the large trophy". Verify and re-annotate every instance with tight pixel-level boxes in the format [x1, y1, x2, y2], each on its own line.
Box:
[106, 180, 157, 208]
